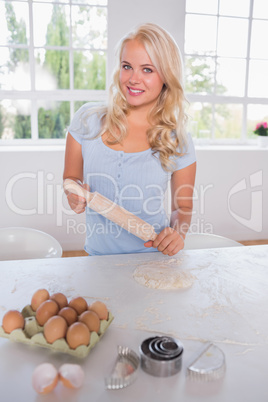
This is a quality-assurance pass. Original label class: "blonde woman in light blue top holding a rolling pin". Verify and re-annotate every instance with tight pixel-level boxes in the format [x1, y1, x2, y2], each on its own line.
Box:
[63, 24, 196, 256]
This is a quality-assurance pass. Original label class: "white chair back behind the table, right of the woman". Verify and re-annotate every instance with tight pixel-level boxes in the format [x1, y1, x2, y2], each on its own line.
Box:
[184, 233, 244, 250]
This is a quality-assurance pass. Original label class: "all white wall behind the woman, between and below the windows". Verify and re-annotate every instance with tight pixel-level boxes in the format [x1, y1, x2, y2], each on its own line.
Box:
[0, 0, 268, 250]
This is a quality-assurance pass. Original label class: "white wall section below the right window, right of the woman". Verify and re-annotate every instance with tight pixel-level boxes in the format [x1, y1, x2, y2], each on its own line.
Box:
[192, 147, 268, 240]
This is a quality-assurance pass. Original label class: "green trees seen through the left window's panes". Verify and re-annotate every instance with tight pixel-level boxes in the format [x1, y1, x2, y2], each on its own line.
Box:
[0, 2, 106, 139]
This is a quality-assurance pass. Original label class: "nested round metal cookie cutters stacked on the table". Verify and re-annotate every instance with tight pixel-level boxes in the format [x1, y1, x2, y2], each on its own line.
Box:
[140, 336, 183, 377]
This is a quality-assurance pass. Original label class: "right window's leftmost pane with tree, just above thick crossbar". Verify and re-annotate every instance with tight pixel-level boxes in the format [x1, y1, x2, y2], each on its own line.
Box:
[185, 57, 215, 95]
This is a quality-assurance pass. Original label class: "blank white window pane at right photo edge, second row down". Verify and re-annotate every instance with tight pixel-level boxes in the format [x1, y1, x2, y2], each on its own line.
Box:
[250, 21, 268, 59]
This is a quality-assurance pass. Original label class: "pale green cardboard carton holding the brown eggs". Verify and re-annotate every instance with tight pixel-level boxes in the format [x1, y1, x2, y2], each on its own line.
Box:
[0, 305, 114, 358]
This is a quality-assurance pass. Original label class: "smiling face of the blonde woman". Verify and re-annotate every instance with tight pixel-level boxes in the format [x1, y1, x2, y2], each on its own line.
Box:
[119, 39, 164, 110]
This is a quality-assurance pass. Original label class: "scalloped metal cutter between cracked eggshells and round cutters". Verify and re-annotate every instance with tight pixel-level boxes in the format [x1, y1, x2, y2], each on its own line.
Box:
[105, 346, 140, 389]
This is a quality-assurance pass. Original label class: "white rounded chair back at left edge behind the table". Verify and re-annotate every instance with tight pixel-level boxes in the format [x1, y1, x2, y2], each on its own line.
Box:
[0, 227, 62, 261]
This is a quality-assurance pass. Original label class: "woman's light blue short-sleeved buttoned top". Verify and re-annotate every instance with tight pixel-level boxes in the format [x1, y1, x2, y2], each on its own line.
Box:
[68, 104, 196, 255]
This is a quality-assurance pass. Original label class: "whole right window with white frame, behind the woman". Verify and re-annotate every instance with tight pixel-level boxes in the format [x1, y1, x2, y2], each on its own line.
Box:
[184, 0, 268, 142]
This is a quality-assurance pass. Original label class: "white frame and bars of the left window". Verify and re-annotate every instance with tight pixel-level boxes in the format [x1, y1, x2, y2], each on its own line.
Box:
[0, 0, 108, 146]
